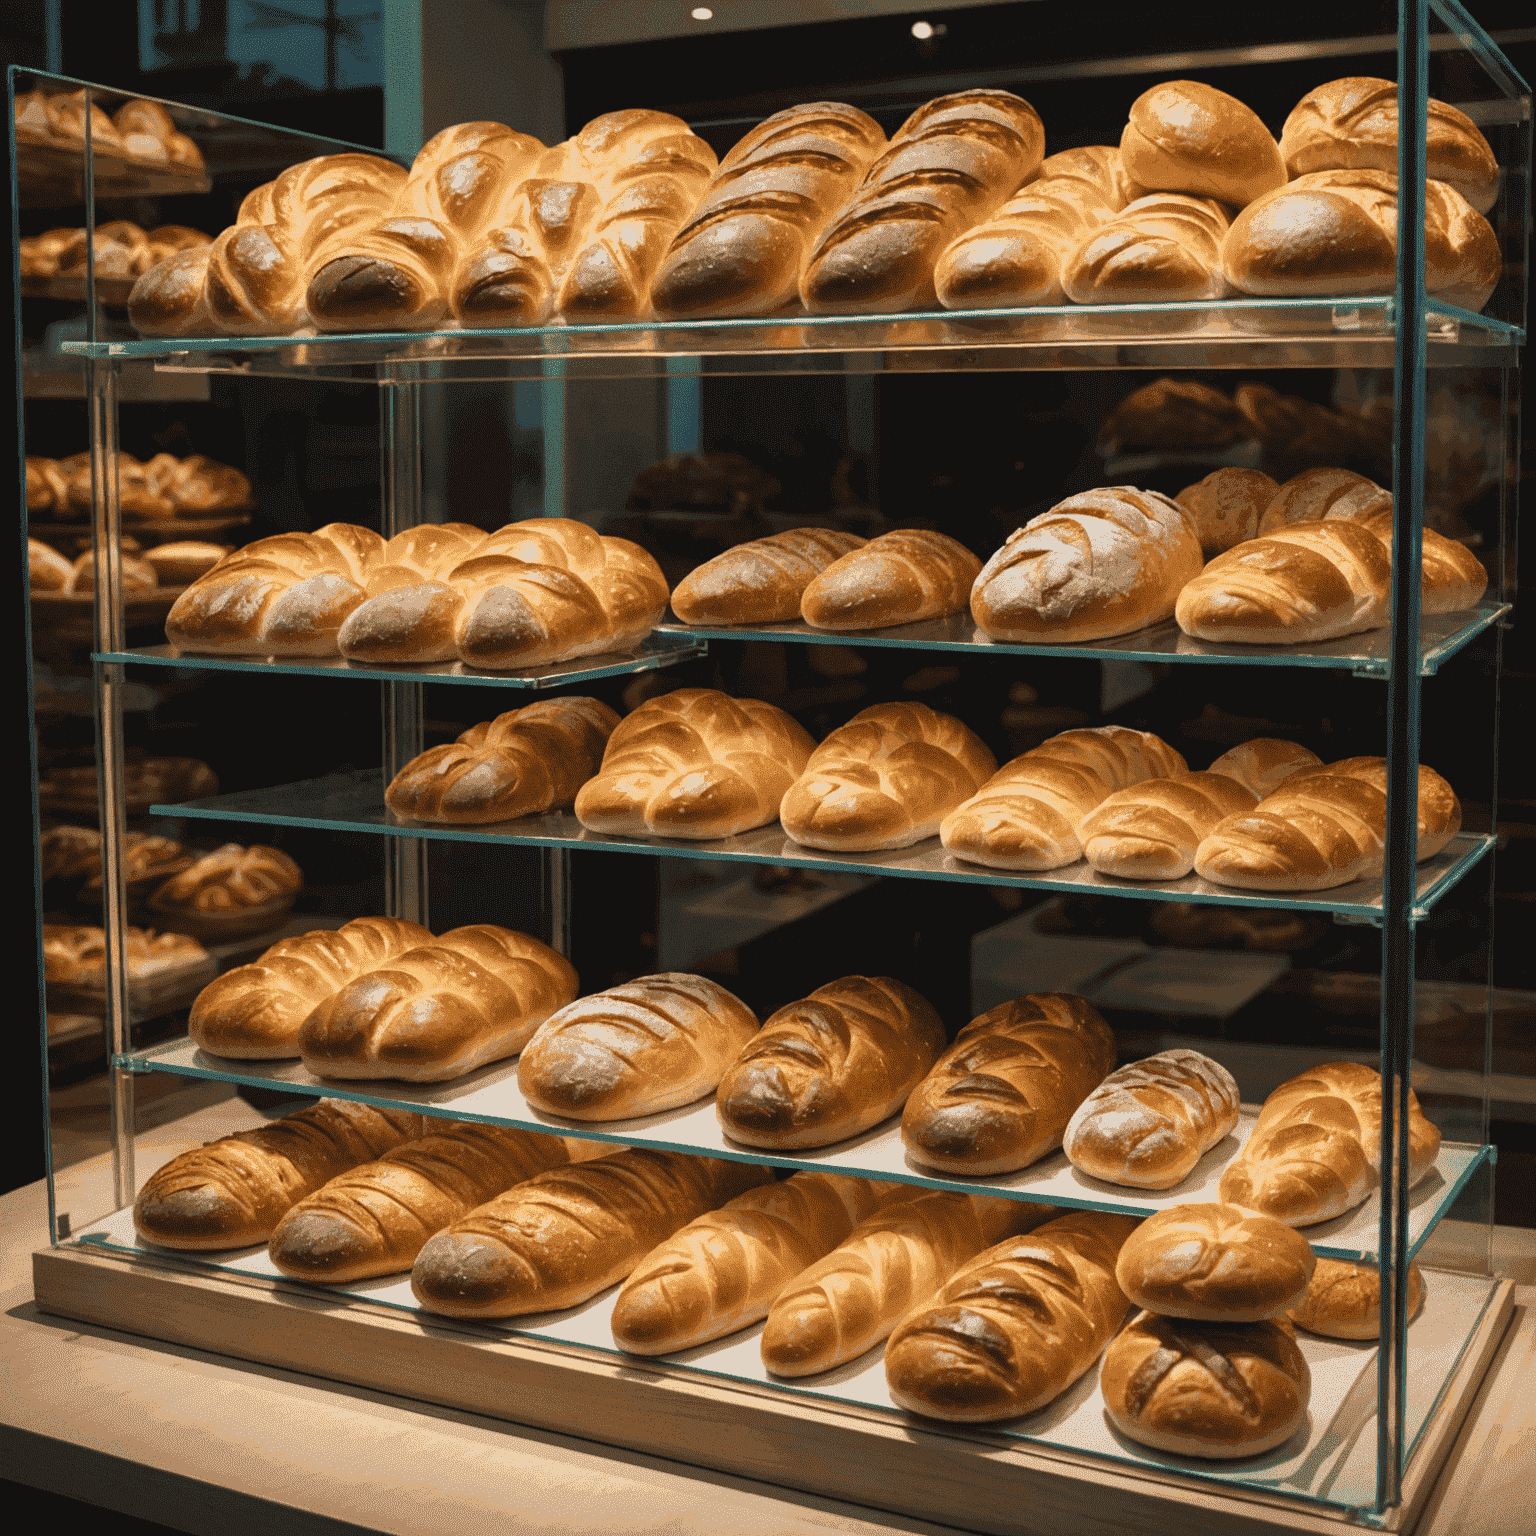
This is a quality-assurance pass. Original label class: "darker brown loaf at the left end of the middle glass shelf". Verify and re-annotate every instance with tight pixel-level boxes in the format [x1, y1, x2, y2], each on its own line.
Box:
[384, 697, 619, 826]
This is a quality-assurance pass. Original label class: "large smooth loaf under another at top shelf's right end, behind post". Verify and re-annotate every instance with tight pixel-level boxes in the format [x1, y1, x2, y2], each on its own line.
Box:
[1221, 170, 1504, 310]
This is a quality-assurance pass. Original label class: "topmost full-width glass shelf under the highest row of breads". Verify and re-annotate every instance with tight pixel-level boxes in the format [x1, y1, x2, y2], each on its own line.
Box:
[66, 296, 1525, 384]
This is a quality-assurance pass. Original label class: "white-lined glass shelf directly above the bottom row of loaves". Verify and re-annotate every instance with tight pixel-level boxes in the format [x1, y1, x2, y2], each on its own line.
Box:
[115, 1038, 1491, 1261]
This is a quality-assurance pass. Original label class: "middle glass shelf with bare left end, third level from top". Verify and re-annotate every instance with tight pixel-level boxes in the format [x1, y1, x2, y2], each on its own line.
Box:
[149, 768, 1493, 923]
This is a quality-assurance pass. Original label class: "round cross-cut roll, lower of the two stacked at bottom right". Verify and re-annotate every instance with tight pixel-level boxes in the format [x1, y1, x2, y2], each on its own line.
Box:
[1100, 1312, 1312, 1459]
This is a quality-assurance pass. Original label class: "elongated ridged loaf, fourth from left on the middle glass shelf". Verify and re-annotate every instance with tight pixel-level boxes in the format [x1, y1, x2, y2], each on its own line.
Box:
[940, 725, 1189, 869]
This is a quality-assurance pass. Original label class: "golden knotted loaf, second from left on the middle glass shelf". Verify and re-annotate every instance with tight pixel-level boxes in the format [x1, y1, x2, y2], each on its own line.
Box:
[576, 688, 816, 840]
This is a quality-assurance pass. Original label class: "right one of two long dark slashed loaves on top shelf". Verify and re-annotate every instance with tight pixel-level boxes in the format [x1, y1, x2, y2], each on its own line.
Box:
[800, 91, 1046, 315]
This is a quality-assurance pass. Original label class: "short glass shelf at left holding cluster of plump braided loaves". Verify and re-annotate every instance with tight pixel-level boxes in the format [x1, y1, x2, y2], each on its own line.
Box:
[91, 631, 710, 688]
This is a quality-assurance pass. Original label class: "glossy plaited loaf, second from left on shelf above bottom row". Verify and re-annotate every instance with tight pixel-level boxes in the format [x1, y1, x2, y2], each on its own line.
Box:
[298, 923, 576, 1083]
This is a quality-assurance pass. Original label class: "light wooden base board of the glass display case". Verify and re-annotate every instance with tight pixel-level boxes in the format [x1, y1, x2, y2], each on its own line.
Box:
[32, 1246, 1514, 1536]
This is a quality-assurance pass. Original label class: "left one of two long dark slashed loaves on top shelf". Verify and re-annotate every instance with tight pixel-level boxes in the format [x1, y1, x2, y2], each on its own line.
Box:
[651, 101, 885, 319]
